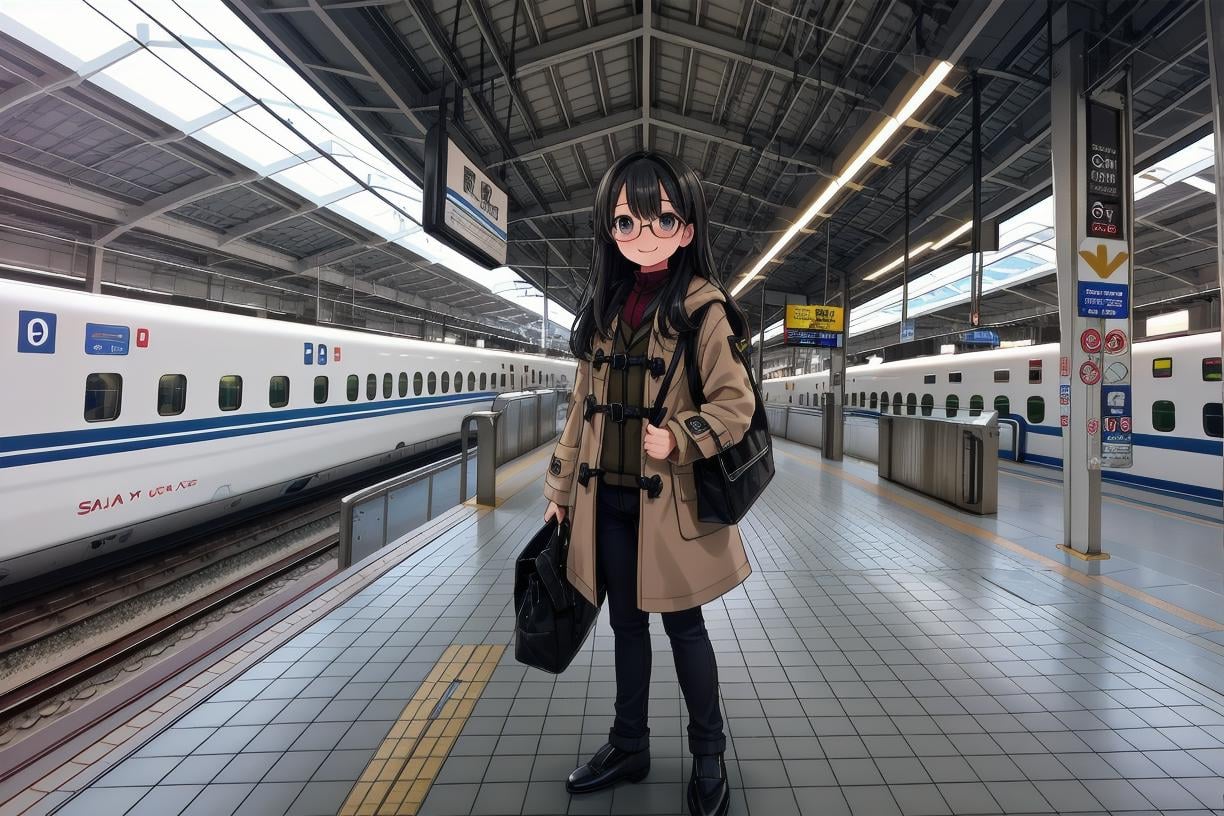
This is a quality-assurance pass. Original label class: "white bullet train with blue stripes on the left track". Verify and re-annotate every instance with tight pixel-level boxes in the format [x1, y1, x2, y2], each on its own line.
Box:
[0, 281, 574, 586]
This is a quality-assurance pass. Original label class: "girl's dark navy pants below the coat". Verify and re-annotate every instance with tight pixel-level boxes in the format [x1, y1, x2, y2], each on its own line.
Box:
[595, 483, 727, 754]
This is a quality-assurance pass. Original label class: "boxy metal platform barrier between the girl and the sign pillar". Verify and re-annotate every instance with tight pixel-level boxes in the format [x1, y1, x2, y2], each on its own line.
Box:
[879, 411, 999, 515]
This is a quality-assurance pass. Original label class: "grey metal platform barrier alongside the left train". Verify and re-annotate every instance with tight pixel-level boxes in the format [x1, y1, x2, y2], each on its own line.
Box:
[340, 389, 568, 569]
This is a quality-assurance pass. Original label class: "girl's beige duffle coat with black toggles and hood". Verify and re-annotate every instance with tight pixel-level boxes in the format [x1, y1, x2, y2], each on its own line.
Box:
[543, 276, 755, 612]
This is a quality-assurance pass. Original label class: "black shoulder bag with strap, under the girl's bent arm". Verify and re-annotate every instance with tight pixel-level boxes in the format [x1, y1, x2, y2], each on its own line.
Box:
[676, 303, 774, 524]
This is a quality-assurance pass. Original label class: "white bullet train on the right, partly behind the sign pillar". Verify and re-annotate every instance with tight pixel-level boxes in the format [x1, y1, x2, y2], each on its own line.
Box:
[763, 332, 1224, 505]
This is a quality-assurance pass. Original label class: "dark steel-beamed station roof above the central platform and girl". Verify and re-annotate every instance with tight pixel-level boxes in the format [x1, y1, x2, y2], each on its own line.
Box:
[228, 0, 1214, 354]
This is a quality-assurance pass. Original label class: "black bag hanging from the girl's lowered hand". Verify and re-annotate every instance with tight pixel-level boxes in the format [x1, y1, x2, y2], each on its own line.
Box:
[514, 519, 603, 674]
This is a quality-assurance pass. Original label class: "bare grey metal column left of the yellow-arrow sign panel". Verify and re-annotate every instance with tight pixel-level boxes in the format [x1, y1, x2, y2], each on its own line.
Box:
[1042, 6, 1100, 555]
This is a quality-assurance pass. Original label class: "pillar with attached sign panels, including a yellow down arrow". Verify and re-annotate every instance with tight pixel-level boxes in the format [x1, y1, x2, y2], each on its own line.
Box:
[1047, 6, 1131, 559]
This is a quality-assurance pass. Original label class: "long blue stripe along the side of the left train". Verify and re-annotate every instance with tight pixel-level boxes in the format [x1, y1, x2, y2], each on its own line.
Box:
[0, 391, 497, 453]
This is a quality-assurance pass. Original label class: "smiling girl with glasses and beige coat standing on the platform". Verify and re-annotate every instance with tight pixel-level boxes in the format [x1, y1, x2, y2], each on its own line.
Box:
[545, 152, 755, 816]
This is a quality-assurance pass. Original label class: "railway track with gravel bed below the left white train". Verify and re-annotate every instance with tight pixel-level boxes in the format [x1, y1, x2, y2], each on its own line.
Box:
[0, 445, 458, 747]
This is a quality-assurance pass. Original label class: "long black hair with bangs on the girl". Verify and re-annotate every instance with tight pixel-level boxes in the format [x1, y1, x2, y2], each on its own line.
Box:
[569, 150, 748, 358]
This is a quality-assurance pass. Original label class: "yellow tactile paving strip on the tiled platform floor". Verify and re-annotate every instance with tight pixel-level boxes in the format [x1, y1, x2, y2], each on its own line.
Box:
[340, 644, 506, 816]
